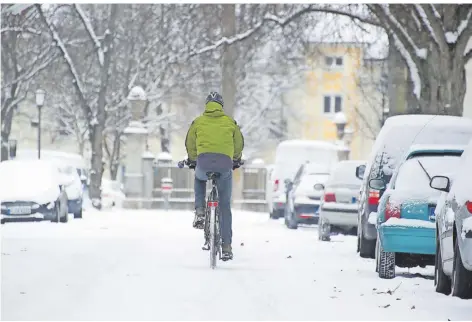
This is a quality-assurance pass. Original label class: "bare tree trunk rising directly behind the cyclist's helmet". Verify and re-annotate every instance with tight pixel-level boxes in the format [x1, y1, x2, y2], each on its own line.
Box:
[221, 4, 236, 117]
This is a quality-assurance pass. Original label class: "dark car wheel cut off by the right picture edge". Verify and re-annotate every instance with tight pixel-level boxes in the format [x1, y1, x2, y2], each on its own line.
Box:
[452, 237, 472, 299]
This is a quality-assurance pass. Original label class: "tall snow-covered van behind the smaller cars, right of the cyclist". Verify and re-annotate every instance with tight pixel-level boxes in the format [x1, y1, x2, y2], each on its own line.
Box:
[267, 140, 339, 219]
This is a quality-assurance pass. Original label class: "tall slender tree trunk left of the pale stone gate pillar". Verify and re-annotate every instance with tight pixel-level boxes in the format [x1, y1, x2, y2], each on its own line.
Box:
[90, 4, 118, 208]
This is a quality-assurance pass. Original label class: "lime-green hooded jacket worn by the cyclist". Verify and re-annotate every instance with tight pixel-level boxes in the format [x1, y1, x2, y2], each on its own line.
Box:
[185, 102, 244, 161]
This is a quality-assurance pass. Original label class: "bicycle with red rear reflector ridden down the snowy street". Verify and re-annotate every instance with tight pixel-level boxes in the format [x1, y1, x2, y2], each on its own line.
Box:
[178, 160, 244, 269]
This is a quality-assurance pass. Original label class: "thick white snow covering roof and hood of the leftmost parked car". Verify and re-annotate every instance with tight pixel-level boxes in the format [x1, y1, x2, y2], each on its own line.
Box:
[0, 160, 60, 205]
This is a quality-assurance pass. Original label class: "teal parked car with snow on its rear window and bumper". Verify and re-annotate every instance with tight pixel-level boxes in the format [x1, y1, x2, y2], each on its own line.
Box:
[369, 145, 464, 278]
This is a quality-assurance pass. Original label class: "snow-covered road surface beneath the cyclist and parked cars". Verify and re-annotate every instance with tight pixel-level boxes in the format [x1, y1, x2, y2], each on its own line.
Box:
[1, 211, 472, 321]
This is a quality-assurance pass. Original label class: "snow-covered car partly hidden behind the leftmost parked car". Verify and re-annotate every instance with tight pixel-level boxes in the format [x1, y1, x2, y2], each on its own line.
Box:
[51, 159, 84, 218]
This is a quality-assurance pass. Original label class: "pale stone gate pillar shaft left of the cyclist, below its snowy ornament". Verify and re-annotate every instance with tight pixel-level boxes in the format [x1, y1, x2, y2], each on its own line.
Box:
[124, 125, 147, 208]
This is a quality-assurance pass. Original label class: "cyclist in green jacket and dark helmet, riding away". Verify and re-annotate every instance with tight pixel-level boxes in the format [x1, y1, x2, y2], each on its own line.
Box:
[185, 92, 244, 259]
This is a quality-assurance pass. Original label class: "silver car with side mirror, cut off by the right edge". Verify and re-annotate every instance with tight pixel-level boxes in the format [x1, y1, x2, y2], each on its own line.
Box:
[430, 140, 472, 299]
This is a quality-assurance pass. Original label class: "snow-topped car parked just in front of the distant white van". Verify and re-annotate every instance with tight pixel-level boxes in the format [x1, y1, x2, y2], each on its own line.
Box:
[284, 162, 329, 229]
